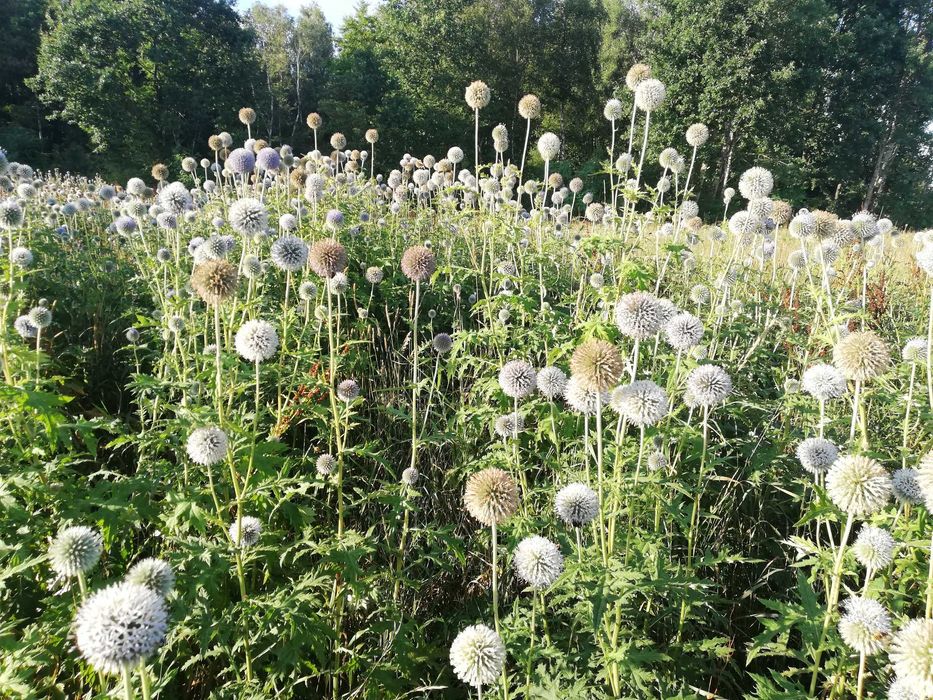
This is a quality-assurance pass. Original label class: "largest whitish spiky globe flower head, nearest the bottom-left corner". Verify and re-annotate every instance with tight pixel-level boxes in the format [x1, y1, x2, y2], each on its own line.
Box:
[74, 582, 168, 674]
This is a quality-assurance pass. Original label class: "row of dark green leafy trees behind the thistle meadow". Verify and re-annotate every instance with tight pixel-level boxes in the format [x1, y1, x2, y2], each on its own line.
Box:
[0, 0, 933, 227]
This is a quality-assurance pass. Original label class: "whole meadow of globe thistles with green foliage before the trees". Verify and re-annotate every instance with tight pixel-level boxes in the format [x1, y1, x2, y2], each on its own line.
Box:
[0, 65, 933, 700]
